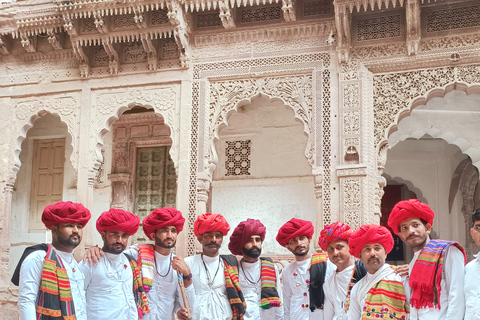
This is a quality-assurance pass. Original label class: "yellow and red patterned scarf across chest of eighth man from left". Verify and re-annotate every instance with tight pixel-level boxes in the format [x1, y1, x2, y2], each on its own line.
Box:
[362, 280, 410, 320]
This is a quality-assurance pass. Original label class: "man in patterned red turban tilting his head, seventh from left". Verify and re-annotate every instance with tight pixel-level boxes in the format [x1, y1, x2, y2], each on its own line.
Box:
[318, 222, 367, 319]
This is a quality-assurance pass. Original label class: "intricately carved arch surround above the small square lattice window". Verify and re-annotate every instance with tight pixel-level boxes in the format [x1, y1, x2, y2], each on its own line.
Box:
[205, 73, 314, 174]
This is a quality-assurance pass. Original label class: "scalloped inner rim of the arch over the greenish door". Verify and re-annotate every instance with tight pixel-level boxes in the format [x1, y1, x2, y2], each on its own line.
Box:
[93, 102, 178, 170]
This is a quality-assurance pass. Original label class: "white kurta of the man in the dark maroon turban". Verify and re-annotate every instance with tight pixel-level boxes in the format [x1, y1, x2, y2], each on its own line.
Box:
[238, 259, 283, 320]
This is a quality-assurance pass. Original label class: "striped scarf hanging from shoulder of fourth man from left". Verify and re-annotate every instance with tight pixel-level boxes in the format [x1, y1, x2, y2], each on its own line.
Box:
[220, 255, 246, 320]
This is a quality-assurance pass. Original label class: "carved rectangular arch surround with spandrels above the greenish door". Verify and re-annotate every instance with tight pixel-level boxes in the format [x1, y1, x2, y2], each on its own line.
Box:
[91, 85, 180, 172]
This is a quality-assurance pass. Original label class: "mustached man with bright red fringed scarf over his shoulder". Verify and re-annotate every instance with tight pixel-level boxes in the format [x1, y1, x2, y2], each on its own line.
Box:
[388, 199, 466, 320]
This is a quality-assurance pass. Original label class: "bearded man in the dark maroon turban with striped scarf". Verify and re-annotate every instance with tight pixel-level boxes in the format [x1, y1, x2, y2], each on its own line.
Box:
[228, 219, 283, 320]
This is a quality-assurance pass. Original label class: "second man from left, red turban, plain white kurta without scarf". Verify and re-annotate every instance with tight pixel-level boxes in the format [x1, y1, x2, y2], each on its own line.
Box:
[80, 209, 141, 320]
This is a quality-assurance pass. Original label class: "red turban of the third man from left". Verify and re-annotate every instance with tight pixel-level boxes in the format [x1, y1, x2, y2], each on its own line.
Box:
[143, 207, 185, 240]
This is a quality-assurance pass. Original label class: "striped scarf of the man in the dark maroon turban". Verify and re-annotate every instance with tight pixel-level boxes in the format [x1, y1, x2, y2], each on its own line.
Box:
[260, 258, 282, 309]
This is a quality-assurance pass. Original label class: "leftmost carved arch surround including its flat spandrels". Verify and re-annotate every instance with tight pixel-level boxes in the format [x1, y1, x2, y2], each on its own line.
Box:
[12, 93, 80, 176]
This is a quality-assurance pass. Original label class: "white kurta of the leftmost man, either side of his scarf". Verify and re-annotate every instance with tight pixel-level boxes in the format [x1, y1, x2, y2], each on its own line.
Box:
[18, 247, 87, 320]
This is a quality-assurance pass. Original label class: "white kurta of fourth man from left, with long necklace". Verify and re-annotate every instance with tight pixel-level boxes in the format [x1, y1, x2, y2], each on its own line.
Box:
[185, 254, 233, 320]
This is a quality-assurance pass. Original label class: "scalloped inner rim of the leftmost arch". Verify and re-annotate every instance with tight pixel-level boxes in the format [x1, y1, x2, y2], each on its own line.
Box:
[12, 109, 76, 176]
